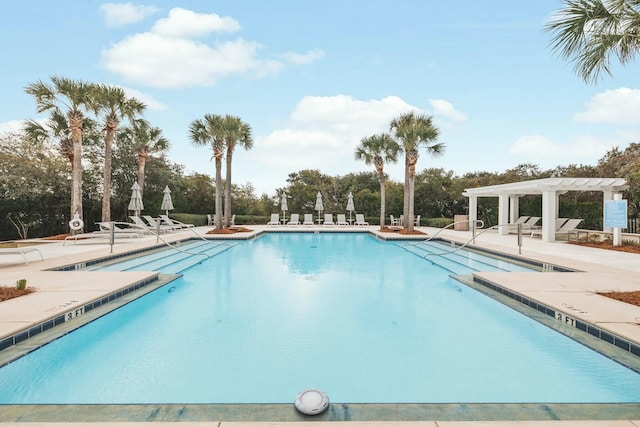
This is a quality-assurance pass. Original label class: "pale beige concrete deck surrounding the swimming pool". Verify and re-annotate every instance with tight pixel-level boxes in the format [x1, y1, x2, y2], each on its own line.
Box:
[0, 226, 640, 427]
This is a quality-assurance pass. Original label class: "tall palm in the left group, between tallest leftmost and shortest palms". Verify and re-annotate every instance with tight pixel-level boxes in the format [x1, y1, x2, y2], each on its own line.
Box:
[92, 84, 146, 222]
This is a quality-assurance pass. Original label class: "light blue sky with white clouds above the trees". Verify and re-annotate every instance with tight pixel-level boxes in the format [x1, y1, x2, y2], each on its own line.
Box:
[0, 0, 640, 196]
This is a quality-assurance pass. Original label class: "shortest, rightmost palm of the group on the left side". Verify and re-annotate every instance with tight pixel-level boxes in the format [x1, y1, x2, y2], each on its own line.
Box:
[118, 119, 169, 196]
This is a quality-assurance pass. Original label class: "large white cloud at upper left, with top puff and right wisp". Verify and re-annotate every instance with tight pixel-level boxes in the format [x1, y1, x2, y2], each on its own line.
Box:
[102, 8, 324, 88]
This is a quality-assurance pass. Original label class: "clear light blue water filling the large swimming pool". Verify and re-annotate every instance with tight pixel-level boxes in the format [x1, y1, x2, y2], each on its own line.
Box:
[0, 233, 640, 404]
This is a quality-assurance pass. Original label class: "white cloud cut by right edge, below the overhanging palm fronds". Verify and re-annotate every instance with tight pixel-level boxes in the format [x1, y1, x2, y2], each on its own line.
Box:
[573, 87, 640, 125]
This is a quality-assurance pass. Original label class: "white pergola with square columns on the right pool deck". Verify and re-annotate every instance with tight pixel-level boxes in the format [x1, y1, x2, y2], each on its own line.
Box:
[462, 178, 629, 242]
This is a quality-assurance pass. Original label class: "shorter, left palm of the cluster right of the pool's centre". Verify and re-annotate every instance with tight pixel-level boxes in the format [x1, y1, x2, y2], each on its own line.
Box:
[355, 133, 400, 229]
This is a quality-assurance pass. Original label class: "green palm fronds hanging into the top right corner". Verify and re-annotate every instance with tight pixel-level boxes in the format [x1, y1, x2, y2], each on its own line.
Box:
[545, 0, 640, 83]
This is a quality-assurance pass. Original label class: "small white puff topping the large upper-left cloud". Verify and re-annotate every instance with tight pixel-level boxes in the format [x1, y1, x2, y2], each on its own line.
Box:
[151, 7, 240, 37]
